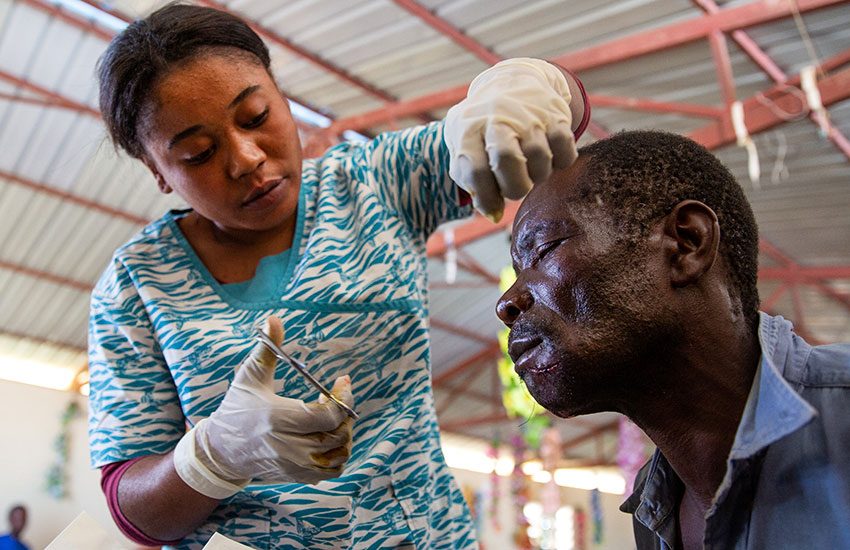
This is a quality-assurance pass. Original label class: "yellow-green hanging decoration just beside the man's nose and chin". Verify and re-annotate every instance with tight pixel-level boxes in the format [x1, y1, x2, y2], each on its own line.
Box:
[498, 268, 550, 449]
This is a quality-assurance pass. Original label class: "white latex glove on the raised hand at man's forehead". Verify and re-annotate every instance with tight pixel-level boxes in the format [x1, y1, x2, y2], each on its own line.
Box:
[443, 57, 578, 222]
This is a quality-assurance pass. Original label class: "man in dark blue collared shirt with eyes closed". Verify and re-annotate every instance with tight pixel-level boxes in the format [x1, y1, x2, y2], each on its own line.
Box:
[496, 131, 850, 550]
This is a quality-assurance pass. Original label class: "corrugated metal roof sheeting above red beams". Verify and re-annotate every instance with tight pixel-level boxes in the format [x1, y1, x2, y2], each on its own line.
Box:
[0, 0, 850, 458]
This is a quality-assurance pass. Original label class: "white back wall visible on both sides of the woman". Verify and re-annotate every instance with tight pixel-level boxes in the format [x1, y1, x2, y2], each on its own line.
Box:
[0, 380, 634, 550]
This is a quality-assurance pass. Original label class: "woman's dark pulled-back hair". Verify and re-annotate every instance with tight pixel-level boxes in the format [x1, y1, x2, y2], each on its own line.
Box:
[97, 4, 271, 158]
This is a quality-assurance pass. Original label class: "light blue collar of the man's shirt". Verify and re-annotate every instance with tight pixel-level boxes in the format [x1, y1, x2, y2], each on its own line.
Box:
[729, 313, 817, 460]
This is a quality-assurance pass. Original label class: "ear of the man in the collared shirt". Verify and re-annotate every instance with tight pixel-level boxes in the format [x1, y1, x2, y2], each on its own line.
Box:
[664, 200, 720, 287]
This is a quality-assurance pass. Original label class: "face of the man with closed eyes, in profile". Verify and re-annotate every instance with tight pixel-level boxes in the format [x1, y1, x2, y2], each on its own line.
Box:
[496, 158, 662, 417]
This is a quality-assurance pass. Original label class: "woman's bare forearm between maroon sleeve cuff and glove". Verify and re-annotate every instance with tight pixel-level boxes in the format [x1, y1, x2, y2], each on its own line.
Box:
[118, 453, 220, 541]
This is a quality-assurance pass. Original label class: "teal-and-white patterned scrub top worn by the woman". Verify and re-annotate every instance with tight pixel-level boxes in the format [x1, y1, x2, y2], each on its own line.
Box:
[89, 123, 477, 550]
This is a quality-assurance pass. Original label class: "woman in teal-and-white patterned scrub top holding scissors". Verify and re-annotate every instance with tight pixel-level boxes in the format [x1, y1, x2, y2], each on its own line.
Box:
[89, 5, 586, 549]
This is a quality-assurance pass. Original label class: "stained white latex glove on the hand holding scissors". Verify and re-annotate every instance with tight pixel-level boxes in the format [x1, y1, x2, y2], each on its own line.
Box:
[173, 317, 354, 499]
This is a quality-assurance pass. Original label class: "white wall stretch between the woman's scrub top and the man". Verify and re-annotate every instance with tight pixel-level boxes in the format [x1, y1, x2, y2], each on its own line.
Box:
[452, 470, 635, 550]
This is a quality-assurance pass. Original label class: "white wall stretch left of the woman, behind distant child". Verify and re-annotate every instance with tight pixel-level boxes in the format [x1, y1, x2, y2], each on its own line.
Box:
[0, 380, 137, 550]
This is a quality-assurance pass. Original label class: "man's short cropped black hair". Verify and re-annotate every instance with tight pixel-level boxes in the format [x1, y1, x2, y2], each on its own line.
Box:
[578, 130, 759, 330]
